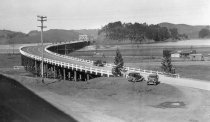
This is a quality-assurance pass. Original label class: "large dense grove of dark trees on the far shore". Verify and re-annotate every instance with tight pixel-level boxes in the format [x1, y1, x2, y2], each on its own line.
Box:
[99, 21, 187, 43]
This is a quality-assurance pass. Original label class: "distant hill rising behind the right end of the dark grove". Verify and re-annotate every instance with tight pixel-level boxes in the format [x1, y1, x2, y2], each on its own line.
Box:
[158, 22, 207, 38]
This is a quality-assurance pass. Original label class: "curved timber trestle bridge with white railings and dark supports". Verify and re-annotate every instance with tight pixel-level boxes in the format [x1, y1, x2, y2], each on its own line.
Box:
[20, 41, 179, 81]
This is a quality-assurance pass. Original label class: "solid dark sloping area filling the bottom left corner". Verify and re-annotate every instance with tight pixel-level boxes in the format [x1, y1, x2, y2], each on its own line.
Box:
[0, 75, 76, 122]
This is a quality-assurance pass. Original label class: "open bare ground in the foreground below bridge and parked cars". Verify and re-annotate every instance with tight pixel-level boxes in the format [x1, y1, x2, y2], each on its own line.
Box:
[6, 77, 210, 122]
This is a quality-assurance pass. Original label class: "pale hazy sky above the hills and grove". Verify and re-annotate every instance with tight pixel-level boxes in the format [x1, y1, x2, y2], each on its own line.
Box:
[0, 0, 210, 33]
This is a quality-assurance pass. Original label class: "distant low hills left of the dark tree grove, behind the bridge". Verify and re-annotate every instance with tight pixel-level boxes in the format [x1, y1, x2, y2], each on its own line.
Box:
[0, 29, 98, 44]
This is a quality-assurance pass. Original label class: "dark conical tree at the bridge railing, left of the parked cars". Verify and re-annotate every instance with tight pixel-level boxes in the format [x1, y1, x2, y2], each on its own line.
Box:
[112, 49, 124, 76]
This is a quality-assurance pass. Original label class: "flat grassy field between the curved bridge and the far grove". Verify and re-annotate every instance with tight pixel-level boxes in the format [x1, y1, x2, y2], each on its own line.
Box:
[69, 45, 210, 81]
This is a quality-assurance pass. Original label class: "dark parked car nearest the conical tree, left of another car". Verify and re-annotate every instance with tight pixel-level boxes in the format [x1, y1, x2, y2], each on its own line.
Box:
[127, 72, 145, 82]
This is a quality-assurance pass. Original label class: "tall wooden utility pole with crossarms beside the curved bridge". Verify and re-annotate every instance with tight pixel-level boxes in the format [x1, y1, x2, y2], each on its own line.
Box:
[37, 16, 47, 83]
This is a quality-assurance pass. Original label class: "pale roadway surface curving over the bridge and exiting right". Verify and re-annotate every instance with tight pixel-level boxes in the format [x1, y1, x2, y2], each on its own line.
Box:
[22, 45, 210, 90]
